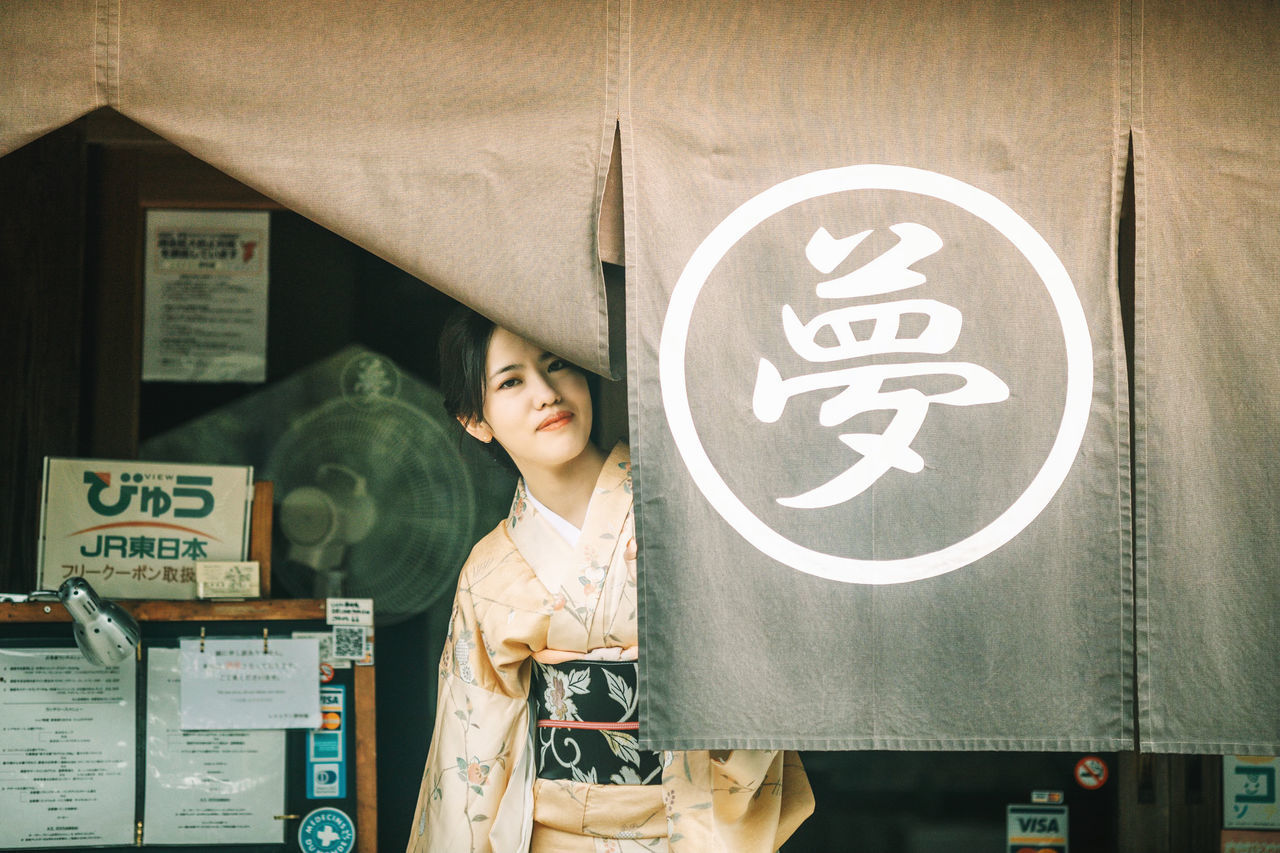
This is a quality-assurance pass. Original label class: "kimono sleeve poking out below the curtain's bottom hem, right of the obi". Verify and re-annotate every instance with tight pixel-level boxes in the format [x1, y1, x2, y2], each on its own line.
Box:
[662, 749, 814, 853]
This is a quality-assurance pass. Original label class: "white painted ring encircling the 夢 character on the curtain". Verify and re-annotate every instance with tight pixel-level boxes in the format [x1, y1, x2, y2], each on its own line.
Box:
[658, 164, 1093, 584]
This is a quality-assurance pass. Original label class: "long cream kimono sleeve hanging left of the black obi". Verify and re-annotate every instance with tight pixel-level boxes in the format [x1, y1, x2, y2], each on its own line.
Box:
[407, 550, 545, 853]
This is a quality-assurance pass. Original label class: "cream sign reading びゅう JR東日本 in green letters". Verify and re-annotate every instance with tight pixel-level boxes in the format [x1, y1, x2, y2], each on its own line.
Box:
[38, 457, 253, 599]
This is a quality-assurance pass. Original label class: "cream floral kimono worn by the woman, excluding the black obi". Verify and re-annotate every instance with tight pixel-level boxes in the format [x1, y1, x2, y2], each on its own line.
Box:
[408, 444, 813, 853]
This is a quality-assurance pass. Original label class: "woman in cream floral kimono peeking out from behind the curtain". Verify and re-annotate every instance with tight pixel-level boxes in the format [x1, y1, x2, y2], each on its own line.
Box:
[408, 313, 813, 853]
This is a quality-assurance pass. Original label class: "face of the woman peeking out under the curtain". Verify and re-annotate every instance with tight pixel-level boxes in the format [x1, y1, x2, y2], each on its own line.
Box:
[463, 327, 591, 473]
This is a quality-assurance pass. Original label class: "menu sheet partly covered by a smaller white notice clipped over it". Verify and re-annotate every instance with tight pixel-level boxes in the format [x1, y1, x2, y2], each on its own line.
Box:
[142, 642, 285, 844]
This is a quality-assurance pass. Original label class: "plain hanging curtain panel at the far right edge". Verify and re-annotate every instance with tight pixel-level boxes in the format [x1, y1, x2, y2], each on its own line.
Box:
[1134, 0, 1280, 754]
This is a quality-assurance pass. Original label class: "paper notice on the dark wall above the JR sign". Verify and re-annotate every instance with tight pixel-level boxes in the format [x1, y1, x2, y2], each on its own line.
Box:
[142, 210, 270, 382]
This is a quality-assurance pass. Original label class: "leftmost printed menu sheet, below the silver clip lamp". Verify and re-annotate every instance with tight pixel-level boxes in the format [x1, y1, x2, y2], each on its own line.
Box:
[0, 648, 137, 849]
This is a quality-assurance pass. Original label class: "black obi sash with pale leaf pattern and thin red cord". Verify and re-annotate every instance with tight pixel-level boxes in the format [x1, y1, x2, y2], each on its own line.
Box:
[529, 661, 662, 785]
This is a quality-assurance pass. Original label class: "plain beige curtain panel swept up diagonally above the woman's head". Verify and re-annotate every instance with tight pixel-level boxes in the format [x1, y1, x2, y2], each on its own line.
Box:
[0, 0, 622, 375]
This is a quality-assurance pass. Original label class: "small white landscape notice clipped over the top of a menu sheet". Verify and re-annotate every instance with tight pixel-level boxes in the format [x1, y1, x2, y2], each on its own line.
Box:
[179, 638, 320, 729]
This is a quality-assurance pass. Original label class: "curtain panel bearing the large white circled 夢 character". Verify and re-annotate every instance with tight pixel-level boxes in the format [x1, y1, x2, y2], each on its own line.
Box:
[623, 0, 1133, 749]
